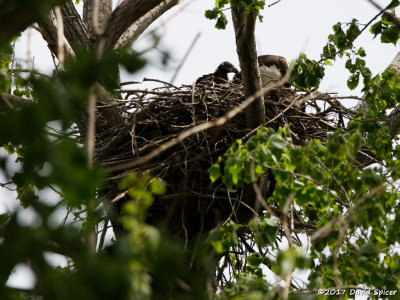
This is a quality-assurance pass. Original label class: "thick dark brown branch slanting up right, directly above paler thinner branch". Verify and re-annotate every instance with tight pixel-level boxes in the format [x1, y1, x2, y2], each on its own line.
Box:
[102, 0, 169, 49]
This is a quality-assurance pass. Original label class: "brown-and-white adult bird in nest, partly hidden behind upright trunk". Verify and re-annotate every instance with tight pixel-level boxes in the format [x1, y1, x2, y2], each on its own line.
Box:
[232, 55, 289, 88]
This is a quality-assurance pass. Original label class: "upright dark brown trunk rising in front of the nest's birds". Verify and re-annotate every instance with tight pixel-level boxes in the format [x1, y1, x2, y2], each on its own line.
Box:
[231, 4, 265, 129]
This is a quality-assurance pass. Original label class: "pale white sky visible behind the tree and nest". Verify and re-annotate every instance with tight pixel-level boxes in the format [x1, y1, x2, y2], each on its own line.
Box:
[0, 0, 398, 299]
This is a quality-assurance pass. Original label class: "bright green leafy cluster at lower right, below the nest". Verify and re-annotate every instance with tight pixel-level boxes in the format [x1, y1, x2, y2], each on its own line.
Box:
[210, 122, 400, 299]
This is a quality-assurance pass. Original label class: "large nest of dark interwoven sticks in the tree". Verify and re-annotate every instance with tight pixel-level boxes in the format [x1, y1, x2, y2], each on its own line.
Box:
[96, 80, 351, 241]
